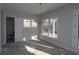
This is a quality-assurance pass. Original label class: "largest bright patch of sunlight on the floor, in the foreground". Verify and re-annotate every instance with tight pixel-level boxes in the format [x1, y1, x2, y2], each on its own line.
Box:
[25, 46, 50, 55]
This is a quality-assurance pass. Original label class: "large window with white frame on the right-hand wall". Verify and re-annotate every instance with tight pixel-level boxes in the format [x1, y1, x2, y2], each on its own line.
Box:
[42, 18, 58, 38]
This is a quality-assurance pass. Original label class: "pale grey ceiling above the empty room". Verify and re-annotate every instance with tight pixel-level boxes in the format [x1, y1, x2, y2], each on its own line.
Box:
[2, 3, 67, 15]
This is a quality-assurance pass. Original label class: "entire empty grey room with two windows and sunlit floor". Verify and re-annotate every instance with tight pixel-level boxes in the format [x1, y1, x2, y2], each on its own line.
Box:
[0, 3, 79, 55]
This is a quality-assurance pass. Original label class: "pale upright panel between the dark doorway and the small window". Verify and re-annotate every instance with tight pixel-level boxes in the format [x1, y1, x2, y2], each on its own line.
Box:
[15, 17, 23, 42]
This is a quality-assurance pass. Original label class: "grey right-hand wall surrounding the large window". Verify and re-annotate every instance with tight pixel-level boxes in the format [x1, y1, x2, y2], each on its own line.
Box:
[40, 4, 79, 54]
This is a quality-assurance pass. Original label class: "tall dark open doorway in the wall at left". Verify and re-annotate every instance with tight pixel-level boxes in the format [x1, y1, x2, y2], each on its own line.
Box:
[6, 17, 15, 43]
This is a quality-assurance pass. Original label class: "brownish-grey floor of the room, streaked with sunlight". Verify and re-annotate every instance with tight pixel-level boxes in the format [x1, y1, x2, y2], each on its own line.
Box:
[2, 39, 74, 55]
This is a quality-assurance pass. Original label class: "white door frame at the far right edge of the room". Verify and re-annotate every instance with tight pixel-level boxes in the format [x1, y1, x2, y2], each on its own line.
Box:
[72, 9, 79, 48]
